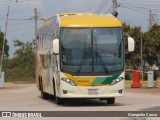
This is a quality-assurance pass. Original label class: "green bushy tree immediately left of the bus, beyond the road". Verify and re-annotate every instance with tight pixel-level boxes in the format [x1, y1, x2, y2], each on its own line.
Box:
[7, 40, 35, 80]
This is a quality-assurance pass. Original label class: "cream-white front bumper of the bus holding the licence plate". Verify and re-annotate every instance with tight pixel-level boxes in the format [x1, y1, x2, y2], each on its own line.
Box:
[59, 81, 124, 98]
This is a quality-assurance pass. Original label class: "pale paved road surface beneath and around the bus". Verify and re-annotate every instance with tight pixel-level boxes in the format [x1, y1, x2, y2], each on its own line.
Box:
[0, 84, 160, 120]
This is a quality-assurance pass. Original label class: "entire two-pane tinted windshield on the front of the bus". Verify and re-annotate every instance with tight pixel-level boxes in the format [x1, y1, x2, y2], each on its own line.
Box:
[60, 28, 124, 74]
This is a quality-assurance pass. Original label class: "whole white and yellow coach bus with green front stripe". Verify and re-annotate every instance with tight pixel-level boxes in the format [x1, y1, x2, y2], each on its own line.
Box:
[36, 13, 134, 104]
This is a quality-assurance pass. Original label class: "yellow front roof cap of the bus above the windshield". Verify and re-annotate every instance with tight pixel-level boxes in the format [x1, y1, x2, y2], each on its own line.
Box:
[59, 13, 122, 27]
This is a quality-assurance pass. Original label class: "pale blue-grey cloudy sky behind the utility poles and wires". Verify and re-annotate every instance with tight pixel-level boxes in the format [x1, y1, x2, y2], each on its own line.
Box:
[0, 0, 160, 58]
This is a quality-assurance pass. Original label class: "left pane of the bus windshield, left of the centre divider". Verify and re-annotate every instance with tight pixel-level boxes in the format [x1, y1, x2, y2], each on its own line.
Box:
[60, 28, 92, 72]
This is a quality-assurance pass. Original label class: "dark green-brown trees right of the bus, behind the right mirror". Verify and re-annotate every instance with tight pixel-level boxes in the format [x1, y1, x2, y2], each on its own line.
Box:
[123, 23, 160, 69]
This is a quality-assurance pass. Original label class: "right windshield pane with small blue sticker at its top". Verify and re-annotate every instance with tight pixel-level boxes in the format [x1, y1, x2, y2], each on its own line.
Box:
[93, 28, 124, 72]
